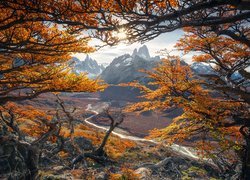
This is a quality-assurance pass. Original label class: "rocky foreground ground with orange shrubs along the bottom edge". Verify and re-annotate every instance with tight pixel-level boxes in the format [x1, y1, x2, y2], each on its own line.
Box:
[39, 143, 221, 180]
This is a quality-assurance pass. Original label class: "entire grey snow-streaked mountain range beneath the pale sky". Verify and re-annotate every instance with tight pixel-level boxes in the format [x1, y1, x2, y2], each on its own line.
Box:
[71, 45, 213, 81]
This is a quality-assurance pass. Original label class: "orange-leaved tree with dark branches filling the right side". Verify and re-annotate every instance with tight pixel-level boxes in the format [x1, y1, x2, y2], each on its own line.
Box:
[123, 1, 250, 178]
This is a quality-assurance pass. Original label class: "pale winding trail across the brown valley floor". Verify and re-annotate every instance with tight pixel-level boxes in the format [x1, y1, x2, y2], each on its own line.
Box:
[84, 103, 199, 159]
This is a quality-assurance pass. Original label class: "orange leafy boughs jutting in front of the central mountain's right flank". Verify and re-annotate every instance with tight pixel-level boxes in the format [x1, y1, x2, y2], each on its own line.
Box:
[123, 56, 200, 111]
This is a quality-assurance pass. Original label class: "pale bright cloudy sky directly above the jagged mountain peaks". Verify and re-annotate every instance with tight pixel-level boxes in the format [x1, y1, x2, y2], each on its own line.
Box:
[74, 30, 193, 63]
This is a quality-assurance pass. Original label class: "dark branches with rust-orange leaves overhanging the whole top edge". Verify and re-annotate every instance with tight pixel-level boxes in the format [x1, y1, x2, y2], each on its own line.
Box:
[0, 0, 250, 45]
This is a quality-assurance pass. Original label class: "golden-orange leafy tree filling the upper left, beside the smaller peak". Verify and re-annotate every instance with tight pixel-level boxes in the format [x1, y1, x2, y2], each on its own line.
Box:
[0, 9, 105, 104]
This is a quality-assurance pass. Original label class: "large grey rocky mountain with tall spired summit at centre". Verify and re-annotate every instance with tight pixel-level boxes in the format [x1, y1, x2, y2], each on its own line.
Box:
[101, 45, 160, 84]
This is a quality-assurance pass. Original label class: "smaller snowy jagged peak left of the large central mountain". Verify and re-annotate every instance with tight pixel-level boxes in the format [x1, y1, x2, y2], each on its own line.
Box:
[72, 55, 105, 77]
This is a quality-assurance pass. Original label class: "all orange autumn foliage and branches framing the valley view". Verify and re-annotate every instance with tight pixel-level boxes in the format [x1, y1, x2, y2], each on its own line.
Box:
[0, 0, 250, 178]
